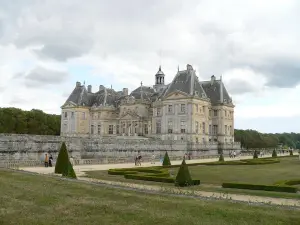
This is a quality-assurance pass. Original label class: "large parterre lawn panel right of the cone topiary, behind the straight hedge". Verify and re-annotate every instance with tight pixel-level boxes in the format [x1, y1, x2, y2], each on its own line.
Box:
[173, 157, 300, 185]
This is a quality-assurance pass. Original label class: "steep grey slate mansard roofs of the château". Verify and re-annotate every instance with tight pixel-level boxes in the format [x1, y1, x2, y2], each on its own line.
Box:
[62, 65, 232, 107]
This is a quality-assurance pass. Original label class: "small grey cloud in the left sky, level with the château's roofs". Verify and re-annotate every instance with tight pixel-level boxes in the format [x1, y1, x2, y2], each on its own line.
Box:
[24, 67, 69, 87]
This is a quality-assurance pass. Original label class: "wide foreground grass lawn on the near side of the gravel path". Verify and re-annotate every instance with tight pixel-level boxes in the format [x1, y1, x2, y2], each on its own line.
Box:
[0, 170, 300, 225]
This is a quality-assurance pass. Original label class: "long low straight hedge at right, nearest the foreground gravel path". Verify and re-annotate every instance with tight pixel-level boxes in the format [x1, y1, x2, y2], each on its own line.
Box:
[222, 183, 298, 193]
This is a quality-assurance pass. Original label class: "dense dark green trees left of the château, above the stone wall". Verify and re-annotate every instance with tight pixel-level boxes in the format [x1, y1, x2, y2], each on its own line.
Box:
[0, 108, 60, 135]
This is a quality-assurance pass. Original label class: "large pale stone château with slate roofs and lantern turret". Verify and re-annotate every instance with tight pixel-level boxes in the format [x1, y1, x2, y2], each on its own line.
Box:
[61, 65, 234, 144]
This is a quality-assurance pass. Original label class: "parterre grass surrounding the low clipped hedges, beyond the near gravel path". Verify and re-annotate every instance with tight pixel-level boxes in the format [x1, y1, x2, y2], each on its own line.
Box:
[86, 157, 300, 199]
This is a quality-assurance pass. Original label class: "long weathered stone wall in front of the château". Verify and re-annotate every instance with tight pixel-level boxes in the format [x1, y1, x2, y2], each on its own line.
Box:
[0, 134, 239, 162]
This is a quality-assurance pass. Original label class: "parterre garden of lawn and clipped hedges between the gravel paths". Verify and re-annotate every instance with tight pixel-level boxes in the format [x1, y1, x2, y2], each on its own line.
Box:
[87, 154, 300, 193]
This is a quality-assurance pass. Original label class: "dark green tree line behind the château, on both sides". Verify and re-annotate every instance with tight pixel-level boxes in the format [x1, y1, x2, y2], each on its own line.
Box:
[0, 108, 300, 149]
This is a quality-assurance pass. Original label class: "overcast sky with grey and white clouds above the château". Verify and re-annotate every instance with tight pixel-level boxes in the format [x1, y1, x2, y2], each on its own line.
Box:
[0, 0, 300, 133]
